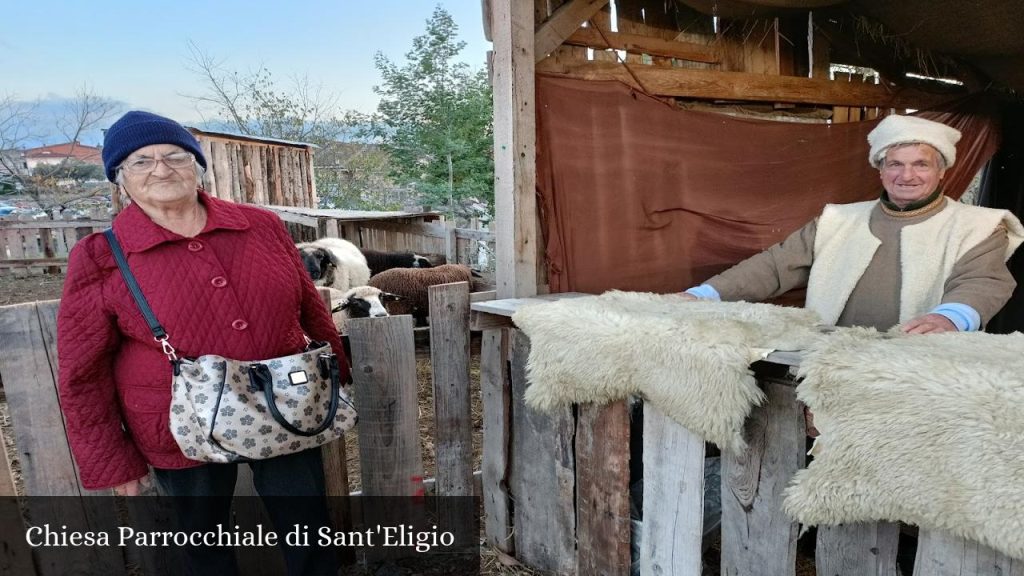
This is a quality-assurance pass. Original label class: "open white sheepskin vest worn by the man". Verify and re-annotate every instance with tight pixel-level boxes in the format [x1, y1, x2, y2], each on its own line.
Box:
[806, 198, 1024, 324]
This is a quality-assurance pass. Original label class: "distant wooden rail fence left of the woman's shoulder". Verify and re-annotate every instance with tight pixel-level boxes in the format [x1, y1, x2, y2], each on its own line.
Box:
[0, 213, 111, 278]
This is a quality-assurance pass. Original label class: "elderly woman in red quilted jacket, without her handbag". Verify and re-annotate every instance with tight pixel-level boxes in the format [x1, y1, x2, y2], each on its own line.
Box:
[57, 112, 347, 574]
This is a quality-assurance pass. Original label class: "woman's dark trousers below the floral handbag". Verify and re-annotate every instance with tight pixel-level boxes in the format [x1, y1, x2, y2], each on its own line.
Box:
[154, 449, 338, 576]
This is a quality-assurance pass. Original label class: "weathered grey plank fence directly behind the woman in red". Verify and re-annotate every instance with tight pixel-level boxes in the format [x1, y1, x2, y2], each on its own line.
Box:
[0, 282, 474, 576]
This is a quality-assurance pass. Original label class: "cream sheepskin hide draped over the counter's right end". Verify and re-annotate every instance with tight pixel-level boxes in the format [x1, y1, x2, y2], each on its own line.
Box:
[785, 329, 1024, 558]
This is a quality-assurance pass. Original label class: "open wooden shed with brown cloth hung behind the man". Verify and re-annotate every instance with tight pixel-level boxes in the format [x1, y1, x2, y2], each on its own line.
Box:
[481, 0, 1024, 576]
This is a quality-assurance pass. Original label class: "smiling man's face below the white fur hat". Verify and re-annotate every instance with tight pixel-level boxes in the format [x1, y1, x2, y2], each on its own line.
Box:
[879, 143, 946, 208]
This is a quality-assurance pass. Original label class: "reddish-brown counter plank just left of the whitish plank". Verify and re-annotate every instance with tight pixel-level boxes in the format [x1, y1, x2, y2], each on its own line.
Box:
[575, 401, 630, 576]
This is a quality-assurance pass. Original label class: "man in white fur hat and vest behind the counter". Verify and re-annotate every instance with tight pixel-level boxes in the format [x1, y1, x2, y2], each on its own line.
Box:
[682, 116, 1024, 334]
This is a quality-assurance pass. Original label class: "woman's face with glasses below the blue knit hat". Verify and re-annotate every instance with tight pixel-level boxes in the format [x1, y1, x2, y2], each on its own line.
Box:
[121, 145, 199, 208]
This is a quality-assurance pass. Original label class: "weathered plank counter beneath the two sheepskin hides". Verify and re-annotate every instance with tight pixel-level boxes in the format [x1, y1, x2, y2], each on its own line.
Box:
[471, 294, 1024, 576]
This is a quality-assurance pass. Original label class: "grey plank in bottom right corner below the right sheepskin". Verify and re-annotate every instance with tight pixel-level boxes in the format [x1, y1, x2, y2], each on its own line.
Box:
[913, 529, 1024, 576]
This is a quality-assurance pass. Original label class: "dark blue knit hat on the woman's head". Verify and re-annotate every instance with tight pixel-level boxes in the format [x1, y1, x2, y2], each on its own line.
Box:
[102, 110, 206, 182]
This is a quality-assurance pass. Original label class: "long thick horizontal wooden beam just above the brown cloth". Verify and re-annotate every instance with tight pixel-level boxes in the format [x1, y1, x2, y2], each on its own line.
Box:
[537, 58, 956, 109]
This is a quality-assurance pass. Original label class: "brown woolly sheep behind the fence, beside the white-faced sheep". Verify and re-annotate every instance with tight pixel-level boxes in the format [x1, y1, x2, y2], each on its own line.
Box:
[370, 264, 474, 326]
